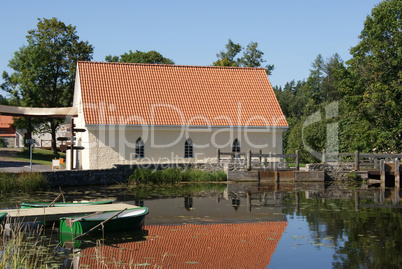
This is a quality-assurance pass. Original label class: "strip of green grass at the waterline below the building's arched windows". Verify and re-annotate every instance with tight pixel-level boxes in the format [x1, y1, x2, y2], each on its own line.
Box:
[128, 168, 227, 184]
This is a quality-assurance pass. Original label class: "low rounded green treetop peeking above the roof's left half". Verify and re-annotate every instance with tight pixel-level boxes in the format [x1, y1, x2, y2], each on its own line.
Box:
[105, 50, 174, 64]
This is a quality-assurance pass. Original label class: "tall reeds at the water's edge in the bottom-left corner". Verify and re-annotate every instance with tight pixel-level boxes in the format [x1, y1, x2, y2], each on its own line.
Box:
[0, 220, 164, 269]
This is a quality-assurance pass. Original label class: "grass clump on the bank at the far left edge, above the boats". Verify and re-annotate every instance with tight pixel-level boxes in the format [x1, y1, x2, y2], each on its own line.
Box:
[0, 172, 49, 193]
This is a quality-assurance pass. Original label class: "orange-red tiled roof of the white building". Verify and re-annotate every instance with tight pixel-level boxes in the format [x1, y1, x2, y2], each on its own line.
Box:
[78, 61, 288, 127]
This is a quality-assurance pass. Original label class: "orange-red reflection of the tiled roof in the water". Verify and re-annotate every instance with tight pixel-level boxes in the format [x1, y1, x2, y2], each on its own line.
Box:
[79, 221, 287, 268]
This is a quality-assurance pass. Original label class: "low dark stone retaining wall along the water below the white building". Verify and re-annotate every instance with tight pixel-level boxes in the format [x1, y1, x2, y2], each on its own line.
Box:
[44, 163, 223, 187]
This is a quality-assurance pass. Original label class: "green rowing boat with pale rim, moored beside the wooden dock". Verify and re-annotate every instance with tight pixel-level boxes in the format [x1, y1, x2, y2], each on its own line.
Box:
[60, 207, 148, 236]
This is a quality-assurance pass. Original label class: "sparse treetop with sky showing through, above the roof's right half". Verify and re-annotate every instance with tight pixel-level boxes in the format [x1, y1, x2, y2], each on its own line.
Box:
[213, 39, 274, 75]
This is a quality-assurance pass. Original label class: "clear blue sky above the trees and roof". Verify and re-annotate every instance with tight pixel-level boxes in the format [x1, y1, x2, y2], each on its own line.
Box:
[0, 0, 381, 94]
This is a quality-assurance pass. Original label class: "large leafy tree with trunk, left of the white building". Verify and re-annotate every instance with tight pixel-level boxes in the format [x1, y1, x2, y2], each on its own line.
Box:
[1, 18, 93, 153]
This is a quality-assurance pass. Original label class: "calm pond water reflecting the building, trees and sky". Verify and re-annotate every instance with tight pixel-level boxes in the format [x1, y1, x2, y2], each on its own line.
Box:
[0, 181, 402, 268]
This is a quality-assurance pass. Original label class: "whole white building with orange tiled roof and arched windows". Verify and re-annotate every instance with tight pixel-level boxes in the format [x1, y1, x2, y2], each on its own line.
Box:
[67, 61, 288, 169]
